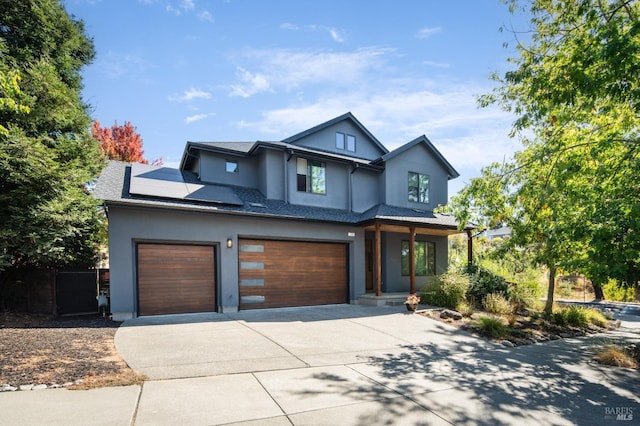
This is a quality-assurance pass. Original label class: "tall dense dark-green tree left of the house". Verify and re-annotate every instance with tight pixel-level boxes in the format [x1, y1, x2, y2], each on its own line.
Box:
[0, 0, 104, 307]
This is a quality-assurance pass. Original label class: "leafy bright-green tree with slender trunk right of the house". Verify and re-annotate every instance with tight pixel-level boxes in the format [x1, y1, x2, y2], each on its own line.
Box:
[453, 0, 640, 311]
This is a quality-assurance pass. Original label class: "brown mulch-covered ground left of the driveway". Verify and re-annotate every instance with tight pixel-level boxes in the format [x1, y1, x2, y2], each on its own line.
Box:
[0, 313, 134, 386]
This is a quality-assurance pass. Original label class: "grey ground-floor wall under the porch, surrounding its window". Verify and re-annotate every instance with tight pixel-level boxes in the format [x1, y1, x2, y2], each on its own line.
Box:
[382, 233, 449, 293]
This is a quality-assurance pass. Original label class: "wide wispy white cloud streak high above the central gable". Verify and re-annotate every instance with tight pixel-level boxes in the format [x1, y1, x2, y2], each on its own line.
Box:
[230, 47, 394, 97]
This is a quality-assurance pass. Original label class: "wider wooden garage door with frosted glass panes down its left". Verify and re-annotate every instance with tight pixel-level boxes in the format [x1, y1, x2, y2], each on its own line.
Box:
[238, 239, 348, 309]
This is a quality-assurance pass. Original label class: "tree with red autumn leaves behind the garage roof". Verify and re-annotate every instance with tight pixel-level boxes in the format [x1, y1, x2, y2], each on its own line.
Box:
[91, 120, 162, 166]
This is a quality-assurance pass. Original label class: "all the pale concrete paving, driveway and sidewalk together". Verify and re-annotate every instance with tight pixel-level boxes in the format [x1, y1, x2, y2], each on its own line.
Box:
[0, 305, 640, 425]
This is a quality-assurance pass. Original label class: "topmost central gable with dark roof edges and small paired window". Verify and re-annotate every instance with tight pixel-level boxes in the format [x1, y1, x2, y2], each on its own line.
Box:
[282, 112, 389, 161]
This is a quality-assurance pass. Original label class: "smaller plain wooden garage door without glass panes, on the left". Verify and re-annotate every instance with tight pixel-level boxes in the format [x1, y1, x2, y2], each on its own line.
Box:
[137, 243, 216, 315]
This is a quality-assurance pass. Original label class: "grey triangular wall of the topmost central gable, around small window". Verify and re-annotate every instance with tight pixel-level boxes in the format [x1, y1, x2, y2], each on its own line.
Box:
[294, 121, 384, 161]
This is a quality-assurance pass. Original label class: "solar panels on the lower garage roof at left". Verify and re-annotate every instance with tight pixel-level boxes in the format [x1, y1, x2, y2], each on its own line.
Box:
[129, 163, 243, 206]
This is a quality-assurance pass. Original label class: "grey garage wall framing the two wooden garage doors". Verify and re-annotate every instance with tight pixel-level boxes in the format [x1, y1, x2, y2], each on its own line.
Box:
[109, 205, 365, 321]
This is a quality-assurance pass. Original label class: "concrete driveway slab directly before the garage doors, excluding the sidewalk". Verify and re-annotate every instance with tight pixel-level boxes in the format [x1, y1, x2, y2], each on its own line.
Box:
[115, 305, 495, 379]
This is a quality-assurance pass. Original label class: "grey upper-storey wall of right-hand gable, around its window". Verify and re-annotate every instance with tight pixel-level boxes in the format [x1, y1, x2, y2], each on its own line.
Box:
[383, 145, 449, 210]
